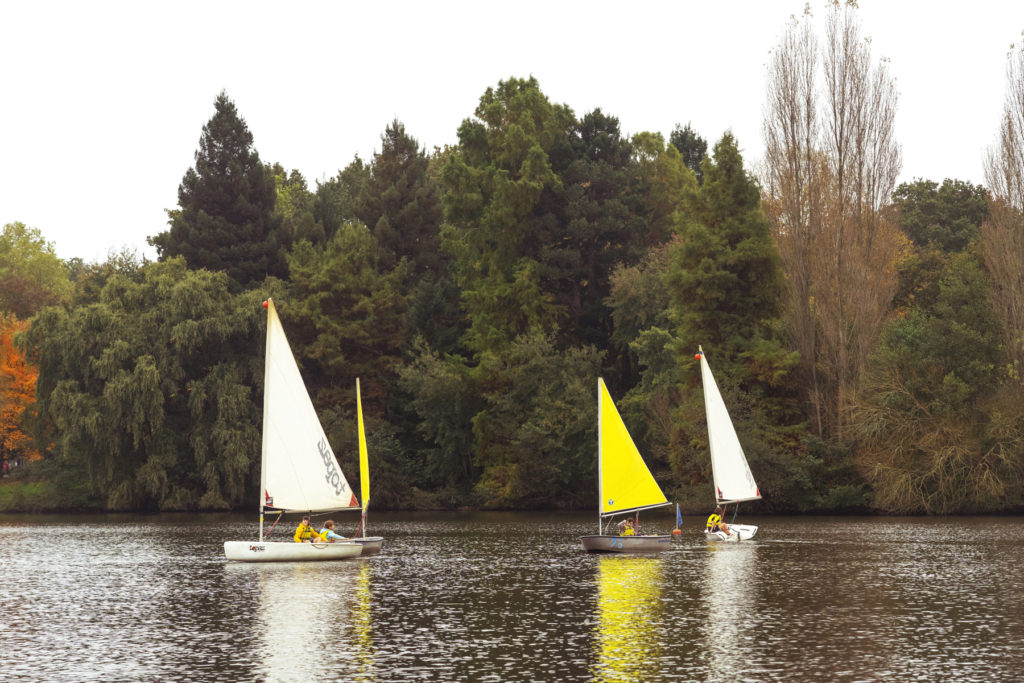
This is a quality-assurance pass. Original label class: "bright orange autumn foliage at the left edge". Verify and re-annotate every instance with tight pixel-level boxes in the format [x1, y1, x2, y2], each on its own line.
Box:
[0, 316, 41, 460]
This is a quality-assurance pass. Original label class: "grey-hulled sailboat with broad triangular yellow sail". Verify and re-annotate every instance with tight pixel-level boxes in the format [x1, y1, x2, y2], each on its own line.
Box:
[580, 378, 672, 553]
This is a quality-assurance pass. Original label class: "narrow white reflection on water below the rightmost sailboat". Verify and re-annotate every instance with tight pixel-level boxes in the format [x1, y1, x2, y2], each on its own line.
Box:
[700, 543, 758, 680]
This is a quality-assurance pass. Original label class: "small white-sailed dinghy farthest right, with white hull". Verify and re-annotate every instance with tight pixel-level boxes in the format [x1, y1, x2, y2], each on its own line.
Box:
[697, 346, 761, 541]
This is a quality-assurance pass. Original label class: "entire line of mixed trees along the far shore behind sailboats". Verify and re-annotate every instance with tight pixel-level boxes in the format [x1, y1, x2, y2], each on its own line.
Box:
[6, 5, 1024, 513]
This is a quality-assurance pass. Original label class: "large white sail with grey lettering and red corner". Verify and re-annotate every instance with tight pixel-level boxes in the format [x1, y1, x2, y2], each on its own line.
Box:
[260, 300, 359, 512]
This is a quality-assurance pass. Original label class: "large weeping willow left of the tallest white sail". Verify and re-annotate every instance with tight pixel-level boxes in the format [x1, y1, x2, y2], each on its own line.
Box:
[28, 259, 261, 509]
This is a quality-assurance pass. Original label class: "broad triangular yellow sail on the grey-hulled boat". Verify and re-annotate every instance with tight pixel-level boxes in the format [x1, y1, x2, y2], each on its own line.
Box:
[597, 379, 668, 515]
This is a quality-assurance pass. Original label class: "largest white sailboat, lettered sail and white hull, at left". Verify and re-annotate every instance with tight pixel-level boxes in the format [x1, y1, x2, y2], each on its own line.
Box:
[224, 299, 362, 562]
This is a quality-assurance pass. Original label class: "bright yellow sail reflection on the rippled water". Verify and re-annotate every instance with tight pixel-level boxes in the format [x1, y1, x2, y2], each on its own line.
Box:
[591, 555, 663, 681]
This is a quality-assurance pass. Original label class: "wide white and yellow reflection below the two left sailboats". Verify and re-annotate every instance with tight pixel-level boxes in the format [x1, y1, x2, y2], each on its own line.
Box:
[226, 561, 377, 681]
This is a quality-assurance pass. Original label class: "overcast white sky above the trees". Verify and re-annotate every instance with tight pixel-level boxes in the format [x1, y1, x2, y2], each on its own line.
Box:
[0, 0, 1024, 261]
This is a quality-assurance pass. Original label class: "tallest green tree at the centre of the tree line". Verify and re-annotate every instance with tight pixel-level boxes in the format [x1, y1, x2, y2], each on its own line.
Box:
[442, 78, 574, 351]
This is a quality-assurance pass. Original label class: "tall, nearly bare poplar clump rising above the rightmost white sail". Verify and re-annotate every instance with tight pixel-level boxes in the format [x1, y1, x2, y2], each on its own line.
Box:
[764, 3, 901, 435]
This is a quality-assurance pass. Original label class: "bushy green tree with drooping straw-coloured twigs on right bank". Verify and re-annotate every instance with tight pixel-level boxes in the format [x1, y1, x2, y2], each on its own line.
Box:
[852, 252, 1024, 514]
